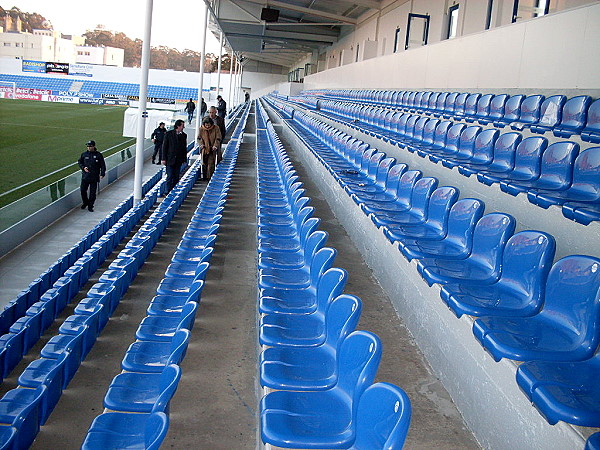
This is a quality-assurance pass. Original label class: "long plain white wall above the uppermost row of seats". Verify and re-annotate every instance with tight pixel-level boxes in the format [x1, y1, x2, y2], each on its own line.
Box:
[304, 3, 600, 96]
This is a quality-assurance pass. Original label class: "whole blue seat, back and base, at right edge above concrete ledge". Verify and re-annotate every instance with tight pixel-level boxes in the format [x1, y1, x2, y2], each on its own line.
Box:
[473, 255, 600, 361]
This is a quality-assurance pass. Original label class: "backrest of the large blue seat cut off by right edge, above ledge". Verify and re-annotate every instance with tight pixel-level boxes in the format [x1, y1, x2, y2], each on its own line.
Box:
[540, 255, 600, 351]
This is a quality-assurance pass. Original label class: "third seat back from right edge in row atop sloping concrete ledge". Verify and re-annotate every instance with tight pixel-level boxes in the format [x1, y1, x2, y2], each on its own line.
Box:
[470, 213, 516, 268]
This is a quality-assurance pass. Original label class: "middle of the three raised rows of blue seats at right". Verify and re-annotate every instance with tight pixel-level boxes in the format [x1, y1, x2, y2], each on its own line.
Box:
[274, 96, 600, 225]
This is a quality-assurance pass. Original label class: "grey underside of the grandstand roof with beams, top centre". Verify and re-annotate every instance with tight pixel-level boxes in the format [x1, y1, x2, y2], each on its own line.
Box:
[211, 0, 381, 67]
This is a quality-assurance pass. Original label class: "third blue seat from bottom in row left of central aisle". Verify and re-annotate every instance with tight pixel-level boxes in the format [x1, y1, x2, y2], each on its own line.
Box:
[121, 328, 191, 373]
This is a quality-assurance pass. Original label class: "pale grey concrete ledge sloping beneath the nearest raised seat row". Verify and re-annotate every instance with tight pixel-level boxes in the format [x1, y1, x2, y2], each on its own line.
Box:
[278, 114, 585, 449]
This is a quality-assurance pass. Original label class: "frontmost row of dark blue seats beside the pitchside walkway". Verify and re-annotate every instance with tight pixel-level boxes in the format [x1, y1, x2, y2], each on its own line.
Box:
[0, 172, 162, 335]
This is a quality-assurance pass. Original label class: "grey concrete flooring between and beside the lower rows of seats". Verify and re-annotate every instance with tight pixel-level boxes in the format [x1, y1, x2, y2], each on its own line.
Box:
[0, 106, 479, 449]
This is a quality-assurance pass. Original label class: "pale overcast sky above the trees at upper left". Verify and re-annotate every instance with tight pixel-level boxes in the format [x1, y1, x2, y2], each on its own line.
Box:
[7, 0, 219, 55]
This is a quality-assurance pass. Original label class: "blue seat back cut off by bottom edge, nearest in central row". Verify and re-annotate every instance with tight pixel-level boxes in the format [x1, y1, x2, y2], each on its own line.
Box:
[351, 383, 412, 450]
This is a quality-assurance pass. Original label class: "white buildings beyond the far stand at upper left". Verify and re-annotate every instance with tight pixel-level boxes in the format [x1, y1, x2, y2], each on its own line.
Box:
[0, 14, 125, 67]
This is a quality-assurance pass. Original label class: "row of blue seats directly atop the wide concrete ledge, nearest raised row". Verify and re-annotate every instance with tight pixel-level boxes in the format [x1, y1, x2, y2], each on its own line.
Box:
[270, 101, 600, 432]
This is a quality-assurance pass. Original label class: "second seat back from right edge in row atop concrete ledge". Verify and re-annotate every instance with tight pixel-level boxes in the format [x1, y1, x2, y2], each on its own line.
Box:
[502, 231, 556, 302]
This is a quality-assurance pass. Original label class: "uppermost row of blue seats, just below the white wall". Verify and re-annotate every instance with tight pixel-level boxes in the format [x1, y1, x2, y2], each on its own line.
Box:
[289, 90, 600, 143]
